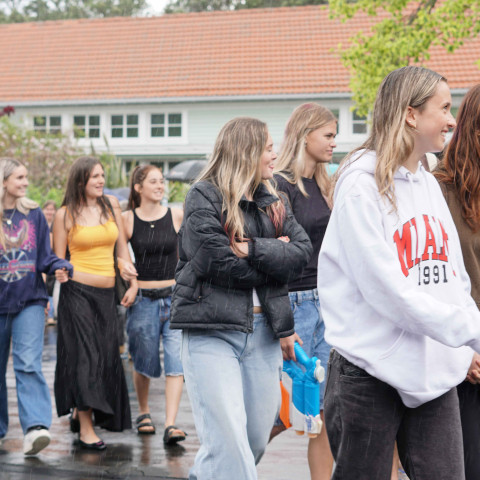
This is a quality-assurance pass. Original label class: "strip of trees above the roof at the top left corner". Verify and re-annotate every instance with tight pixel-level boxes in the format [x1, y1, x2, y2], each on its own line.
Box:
[0, 0, 147, 23]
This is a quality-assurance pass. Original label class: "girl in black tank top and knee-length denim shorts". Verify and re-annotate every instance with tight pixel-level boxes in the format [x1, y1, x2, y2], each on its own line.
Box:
[122, 165, 186, 445]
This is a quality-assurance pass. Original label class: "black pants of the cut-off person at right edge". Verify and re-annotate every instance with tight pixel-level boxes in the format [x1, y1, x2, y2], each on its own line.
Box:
[457, 382, 480, 480]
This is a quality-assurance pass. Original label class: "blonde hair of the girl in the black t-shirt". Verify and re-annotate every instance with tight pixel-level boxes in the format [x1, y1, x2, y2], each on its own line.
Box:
[275, 103, 337, 202]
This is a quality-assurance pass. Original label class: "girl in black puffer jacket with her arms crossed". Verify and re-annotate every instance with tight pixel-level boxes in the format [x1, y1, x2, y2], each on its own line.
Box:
[171, 118, 312, 480]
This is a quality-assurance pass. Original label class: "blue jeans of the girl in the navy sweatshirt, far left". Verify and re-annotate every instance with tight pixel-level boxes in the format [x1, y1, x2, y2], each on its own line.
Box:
[0, 305, 52, 438]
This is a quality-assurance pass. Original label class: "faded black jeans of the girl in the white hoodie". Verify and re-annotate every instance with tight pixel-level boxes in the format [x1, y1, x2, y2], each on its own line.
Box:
[324, 350, 464, 480]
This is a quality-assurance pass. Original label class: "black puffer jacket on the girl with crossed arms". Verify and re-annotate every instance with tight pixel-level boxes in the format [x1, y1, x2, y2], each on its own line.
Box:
[171, 182, 312, 338]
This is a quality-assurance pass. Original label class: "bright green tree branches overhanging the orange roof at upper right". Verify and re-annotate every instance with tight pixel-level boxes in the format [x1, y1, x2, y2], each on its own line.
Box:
[329, 0, 480, 115]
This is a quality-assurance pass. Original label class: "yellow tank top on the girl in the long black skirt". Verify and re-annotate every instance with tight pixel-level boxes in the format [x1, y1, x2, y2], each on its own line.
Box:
[68, 218, 118, 277]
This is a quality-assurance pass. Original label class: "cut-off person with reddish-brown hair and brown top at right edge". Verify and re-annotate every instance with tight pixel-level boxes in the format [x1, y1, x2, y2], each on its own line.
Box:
[434, 85, 480, 480]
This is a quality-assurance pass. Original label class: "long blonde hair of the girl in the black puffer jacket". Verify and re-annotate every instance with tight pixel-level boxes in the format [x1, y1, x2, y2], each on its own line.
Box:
[196, 117, 285, 251]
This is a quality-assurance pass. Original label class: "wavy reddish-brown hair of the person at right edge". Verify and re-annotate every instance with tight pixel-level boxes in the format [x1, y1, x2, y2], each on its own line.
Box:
[434, 84, 480, 232]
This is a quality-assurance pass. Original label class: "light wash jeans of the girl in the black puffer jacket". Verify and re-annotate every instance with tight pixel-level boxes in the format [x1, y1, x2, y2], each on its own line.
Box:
[182, 314, 282, 480]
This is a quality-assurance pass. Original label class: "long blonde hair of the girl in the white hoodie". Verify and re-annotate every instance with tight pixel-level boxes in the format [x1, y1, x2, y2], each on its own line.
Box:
[344, 66, 447, 210]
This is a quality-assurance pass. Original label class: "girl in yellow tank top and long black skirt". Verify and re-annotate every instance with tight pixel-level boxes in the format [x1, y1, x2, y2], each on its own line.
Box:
[53, 157, 136, 450]
